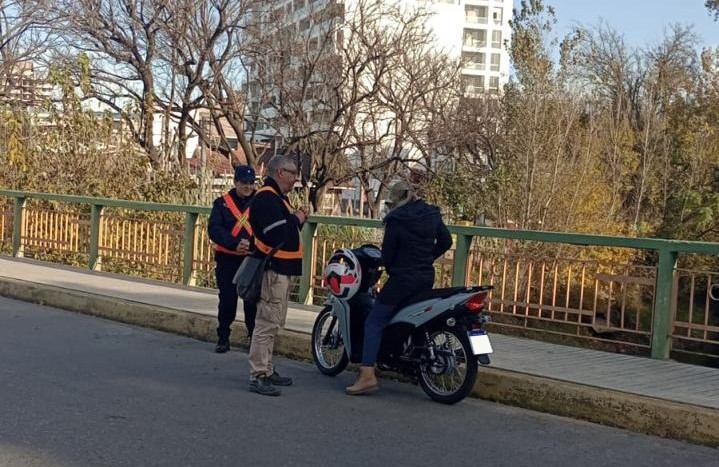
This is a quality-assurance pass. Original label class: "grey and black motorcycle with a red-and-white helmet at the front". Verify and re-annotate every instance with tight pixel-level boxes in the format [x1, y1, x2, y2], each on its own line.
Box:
[312, 245, 493, 404]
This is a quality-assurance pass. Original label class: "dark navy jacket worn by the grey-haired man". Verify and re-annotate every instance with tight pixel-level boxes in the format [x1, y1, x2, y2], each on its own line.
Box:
[250, 177, 302, 276]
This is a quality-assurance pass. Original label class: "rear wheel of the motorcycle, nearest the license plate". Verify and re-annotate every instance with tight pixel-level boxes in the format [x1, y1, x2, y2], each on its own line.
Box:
[419, 326, 478, 404]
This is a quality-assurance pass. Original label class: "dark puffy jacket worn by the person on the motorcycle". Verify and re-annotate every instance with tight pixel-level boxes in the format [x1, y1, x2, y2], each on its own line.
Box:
[382, 199, 452, 281]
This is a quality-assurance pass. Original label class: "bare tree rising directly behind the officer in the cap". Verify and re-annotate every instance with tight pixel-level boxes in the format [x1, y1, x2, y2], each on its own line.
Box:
[161, 0, 264, 164]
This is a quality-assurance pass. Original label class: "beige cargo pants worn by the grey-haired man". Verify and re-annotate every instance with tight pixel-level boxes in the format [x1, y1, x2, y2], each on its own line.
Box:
[249, 270, 291, 380]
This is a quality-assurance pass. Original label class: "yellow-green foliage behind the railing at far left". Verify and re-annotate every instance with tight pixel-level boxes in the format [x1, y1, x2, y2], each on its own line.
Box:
[0, 56, 197, 203]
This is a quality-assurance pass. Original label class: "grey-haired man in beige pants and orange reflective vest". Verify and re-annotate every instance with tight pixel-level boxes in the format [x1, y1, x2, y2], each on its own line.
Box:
[249, 154, 309, 396]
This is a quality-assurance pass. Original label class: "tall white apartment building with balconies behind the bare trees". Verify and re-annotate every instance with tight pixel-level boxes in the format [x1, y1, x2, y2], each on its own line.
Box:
[247, 0, 513, 141]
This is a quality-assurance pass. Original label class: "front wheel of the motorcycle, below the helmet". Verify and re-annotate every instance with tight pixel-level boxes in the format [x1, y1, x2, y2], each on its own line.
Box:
[312, 306, 349, 376]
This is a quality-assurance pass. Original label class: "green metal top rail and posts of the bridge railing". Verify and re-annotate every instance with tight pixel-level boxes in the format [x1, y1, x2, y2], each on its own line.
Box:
[0, 190, 719, 359]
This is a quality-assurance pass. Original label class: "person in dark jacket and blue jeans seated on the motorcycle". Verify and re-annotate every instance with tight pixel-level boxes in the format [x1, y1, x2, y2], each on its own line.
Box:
[346, 181, 452, 395]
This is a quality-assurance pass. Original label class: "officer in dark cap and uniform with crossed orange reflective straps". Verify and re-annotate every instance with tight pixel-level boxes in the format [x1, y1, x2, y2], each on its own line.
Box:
[208, 165, 257, 353]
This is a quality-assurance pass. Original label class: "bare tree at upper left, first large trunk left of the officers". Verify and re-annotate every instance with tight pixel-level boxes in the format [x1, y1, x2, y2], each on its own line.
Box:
[29, 0, 175, 165]
